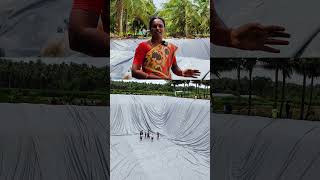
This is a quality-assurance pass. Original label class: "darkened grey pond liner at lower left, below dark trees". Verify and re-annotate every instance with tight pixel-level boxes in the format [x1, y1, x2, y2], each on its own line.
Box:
[0, 103, 110, 180]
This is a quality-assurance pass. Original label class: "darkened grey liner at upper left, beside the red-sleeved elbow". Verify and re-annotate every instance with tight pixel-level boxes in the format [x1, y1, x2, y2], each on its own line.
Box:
[0, 0, 77, 57]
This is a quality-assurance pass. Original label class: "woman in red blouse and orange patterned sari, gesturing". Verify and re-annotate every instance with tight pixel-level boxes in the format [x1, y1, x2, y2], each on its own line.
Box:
[132, 17, 200, 80]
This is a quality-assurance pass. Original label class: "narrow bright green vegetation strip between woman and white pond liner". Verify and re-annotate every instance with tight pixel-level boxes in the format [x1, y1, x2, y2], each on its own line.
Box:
[111, 81, 210, 99]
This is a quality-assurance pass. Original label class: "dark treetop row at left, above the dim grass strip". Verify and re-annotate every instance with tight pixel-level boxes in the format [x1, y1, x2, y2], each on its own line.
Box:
[0, 58, 110, 91]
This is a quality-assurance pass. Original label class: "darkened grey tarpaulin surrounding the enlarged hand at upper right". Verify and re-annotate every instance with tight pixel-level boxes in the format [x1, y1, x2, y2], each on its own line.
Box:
[212, 0, 320, 57]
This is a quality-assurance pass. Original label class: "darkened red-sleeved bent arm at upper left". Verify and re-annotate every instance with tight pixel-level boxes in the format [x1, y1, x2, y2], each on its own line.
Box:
[69, 0, 110, 57]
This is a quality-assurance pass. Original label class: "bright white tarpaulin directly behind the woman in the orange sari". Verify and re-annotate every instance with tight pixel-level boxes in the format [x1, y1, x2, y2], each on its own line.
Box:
[110, 38, 210, 80]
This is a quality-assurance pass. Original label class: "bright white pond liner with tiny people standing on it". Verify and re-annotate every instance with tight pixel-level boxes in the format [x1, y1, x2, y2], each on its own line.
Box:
[110, 95, 210, 180]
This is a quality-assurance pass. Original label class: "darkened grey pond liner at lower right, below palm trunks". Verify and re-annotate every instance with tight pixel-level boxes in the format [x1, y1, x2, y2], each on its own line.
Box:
[211, 113, 320, 180]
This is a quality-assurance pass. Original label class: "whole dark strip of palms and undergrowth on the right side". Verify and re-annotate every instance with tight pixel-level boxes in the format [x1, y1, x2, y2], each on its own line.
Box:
[211, 59, 320, 120]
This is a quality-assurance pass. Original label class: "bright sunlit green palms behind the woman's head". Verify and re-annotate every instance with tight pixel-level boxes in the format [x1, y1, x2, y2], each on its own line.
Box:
[110, 0, 210, 37]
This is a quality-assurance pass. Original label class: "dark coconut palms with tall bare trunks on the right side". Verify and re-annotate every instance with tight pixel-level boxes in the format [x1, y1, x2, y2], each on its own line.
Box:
[211, 59, 320, 119]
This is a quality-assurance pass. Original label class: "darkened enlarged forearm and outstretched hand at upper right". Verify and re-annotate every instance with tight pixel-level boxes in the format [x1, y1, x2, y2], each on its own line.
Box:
[210, 1, 290, 53]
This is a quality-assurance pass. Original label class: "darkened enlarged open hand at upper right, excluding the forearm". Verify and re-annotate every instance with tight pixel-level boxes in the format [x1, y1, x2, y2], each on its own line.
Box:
[230, 23, 290, 53]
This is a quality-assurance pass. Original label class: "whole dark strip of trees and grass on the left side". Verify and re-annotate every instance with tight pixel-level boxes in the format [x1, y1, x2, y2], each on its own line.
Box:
[0, 59, 109, 105]
